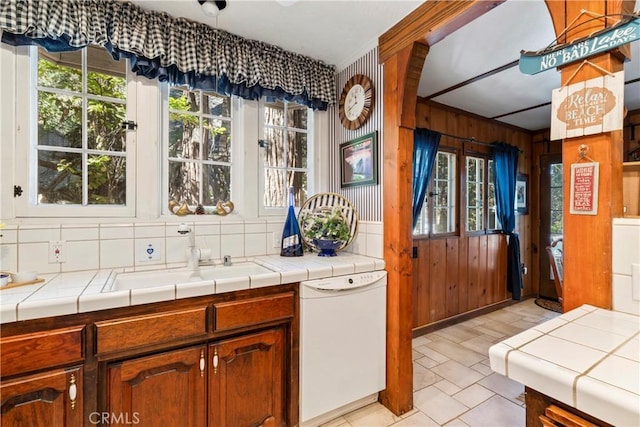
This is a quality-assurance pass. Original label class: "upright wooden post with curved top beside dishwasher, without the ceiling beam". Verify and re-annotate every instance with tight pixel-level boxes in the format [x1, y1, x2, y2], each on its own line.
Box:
[380, 43, 429, 415]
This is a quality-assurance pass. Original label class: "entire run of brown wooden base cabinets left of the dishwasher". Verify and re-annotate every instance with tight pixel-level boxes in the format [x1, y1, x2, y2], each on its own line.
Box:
[0, 284, 299, 427]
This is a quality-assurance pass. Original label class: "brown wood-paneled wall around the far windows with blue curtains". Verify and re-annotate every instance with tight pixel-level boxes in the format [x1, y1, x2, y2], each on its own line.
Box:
[413, 99, 538, 328]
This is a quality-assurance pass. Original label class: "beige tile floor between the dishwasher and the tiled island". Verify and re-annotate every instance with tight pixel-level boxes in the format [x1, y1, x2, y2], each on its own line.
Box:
[321, 298, 559, 427]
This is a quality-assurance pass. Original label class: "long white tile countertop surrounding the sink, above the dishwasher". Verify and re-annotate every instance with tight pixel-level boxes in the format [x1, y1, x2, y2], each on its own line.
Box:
[0, 253, 385, 324]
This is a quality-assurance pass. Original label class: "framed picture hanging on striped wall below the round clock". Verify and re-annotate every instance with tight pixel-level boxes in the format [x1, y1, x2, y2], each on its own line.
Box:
[340, 132, 378, 188]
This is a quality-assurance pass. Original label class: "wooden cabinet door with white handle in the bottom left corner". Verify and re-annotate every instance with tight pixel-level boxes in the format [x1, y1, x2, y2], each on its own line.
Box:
[0, 367, 82, 427]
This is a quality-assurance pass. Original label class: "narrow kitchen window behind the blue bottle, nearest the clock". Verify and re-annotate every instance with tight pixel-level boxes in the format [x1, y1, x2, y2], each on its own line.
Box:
[260, 100, 313, 215]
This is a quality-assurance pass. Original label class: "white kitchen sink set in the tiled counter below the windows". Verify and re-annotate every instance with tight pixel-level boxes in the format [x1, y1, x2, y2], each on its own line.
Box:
[105, 261, 274, 291]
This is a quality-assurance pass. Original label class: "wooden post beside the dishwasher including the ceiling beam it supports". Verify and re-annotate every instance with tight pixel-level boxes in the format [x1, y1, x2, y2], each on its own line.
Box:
[378, 0, 505, 415]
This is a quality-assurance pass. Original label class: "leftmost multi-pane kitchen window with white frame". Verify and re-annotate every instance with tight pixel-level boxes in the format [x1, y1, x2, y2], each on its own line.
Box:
[16, 46, 135, 216]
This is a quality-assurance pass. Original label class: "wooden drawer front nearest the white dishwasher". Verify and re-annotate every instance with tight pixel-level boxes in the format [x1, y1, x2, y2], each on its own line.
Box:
[214, 292, 294, 331]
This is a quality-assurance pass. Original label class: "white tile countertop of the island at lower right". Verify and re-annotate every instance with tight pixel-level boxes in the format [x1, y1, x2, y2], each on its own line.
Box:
[489, 305, 640, 426]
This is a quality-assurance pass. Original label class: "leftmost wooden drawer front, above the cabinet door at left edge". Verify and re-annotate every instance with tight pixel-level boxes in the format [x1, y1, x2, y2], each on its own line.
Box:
[0, 326, 84, 376]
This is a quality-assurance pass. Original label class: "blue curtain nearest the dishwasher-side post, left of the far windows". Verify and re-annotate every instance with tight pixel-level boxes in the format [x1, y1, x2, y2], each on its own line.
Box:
[413, 129, 442, 228]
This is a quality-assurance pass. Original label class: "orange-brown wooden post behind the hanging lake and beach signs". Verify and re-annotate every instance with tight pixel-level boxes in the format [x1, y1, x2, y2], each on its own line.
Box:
[547, 1, 628, 311]
